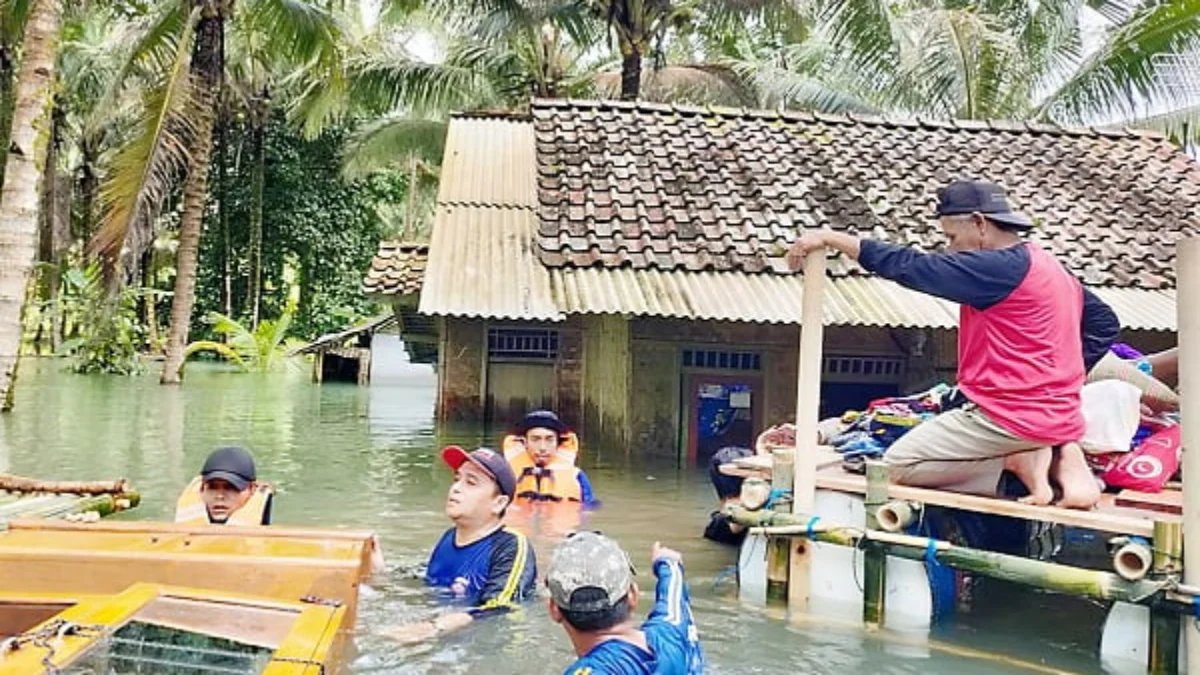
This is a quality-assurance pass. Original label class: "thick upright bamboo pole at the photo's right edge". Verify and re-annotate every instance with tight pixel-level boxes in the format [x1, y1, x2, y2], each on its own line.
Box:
[1175, 237, 1200, 670]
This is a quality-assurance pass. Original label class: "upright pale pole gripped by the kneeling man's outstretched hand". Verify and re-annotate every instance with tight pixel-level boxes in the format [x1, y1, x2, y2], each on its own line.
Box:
[787, 249, 826, 610]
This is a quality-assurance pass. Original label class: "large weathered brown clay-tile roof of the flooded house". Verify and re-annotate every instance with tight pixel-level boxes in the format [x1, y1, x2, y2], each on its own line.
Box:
[532, 100, 1200, 289]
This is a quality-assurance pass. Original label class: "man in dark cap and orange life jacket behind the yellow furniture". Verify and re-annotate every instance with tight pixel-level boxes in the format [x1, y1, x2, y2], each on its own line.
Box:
[175, 447, 274, 526]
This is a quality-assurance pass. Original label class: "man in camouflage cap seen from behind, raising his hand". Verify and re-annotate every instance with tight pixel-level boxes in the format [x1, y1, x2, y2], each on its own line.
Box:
[546, 532, 704, 675]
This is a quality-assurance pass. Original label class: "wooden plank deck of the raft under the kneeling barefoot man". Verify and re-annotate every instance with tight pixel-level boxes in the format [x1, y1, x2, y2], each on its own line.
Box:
[721, 450, 1182, 538]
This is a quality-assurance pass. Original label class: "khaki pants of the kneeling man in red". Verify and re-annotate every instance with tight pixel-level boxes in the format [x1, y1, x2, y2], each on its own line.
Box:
[883, 404, 1045, 497]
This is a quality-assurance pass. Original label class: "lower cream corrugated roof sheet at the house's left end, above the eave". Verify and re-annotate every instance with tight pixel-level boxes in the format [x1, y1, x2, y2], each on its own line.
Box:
[418, 205, 563, 321]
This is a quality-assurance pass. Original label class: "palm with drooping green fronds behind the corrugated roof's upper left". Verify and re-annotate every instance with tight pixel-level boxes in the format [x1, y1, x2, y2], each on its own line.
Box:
[319, 0, 601, 239]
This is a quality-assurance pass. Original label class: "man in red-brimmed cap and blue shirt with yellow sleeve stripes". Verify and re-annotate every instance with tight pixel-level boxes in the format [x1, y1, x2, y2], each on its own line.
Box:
[385, 446, 538, 643]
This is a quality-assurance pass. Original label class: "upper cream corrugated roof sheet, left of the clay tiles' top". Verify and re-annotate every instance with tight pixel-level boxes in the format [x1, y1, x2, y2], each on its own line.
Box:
[438, 118, 538, 209]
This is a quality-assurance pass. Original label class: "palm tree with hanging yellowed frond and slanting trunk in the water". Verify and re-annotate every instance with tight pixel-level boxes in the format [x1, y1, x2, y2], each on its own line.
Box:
[91, 0, 341, 384]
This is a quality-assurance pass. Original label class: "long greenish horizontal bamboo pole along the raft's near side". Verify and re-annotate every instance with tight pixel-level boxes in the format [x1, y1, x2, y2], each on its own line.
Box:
[726, 506, 1194, 615]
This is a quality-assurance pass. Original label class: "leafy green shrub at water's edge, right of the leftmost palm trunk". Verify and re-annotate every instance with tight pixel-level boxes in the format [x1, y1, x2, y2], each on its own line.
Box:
[43, 258, 156, 375]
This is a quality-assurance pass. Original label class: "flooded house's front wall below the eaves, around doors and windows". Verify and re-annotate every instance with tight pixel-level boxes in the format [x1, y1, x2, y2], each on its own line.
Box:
[438, 315, 1176, 459]
